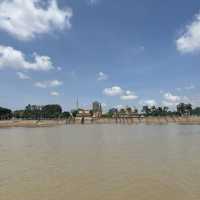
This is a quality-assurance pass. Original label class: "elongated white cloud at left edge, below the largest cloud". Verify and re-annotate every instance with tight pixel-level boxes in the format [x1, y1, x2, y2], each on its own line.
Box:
[0, 45, 54, 71]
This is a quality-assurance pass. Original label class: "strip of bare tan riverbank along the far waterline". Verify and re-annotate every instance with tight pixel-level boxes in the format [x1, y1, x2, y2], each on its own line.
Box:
[0, 116, 200, 128]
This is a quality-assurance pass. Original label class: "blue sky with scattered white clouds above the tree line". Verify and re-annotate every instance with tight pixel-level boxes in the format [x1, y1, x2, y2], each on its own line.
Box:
[0, 0, 200, 110]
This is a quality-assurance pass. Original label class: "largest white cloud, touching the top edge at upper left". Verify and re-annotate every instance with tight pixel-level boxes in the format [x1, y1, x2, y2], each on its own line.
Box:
[0, 0, 72, 41]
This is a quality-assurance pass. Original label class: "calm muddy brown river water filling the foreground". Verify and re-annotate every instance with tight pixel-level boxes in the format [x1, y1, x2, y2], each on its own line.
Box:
[0, 125, 200, 200]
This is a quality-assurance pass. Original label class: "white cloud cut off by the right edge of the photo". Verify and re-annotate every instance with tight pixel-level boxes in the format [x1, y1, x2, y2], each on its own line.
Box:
[176, 13, 200, 53]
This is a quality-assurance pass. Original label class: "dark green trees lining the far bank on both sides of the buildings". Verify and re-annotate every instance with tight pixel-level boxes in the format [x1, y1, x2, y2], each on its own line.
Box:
[0, 103, 200, 120]
